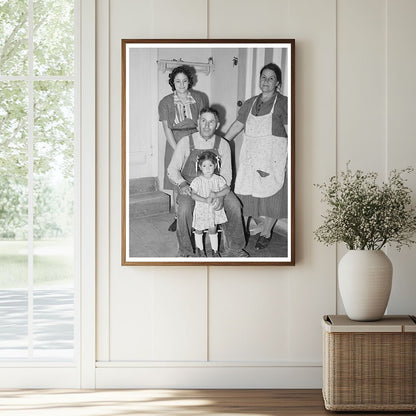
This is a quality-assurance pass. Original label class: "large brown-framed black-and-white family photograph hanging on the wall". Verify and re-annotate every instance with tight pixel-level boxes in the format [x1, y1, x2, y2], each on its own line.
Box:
[121, 39, 295, 266]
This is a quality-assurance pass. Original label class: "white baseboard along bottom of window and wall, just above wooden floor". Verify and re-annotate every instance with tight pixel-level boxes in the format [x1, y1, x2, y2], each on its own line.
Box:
[0, 362, 322, 389]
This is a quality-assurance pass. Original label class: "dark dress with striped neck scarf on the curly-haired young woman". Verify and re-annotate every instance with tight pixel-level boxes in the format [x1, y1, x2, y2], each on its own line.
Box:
[159, 90, 208, 189]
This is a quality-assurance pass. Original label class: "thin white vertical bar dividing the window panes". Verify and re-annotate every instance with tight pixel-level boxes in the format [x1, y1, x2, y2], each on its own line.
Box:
[27, 0, 34, 359]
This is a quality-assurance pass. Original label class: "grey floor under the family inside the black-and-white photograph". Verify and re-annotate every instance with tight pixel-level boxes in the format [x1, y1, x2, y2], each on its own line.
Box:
[130, 214, 287, 257]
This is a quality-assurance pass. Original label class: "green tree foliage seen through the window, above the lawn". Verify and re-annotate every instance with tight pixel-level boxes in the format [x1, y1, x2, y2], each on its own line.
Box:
[0, 0, 74, 239]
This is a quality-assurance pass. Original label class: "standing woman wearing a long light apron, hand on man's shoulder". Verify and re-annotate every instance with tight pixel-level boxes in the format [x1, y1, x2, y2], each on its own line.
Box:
[224, 63, 288, 250]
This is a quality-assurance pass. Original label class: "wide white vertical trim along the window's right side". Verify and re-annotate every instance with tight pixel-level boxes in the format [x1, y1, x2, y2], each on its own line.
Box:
[79, 0, 96, 388]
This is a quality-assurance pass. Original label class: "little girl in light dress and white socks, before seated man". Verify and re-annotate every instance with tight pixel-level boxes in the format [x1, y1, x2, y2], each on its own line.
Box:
[191, 151, 230, 257]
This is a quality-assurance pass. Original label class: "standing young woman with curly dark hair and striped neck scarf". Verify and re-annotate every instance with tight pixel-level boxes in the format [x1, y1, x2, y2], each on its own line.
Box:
[159, 65, 208, 231]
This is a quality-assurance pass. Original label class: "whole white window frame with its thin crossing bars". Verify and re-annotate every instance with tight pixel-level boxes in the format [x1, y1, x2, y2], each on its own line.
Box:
[0, 0, 95, 388]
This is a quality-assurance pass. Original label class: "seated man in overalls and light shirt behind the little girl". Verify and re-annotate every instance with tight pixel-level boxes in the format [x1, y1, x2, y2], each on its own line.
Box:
[167, 108, 248, 257]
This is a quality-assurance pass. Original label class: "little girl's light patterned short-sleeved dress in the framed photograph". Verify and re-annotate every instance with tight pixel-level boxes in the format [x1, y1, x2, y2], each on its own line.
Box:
[191, 174, 227, 230]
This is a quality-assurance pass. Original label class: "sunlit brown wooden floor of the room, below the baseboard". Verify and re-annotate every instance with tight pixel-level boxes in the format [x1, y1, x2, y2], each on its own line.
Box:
[0, 389, 414, 416]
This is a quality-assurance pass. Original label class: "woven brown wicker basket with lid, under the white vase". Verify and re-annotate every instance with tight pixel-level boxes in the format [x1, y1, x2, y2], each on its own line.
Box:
[322, 315, 416, 411]
